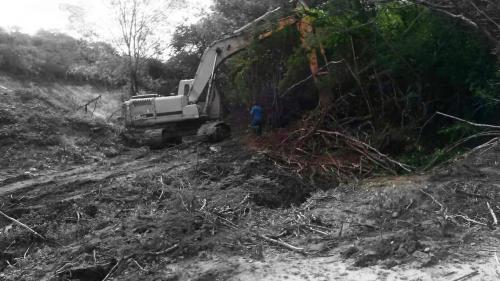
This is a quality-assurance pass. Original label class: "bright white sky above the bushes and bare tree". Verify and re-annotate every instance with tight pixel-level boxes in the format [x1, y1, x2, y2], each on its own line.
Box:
[0, 0, 211, 38]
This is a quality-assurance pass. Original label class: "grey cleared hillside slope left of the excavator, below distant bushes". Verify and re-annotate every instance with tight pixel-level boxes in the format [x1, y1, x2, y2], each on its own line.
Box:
[0, 76, 121, 182]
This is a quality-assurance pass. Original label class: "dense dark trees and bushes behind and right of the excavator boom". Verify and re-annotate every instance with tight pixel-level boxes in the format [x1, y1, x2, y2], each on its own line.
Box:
[169, 0, 500, 162]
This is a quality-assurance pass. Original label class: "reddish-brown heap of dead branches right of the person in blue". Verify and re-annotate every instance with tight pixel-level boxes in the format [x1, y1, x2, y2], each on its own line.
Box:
[263, 109, 411, 179]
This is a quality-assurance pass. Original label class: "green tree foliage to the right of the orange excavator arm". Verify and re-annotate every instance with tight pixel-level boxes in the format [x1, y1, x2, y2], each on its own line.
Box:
[313, 1, 498, 147]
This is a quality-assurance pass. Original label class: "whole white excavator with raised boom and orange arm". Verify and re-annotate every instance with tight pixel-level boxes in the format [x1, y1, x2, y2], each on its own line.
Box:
[123, 1, 318, 143]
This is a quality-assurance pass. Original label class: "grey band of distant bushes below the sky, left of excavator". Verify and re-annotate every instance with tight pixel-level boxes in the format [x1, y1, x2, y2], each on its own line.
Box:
[0, 29, 131, 86]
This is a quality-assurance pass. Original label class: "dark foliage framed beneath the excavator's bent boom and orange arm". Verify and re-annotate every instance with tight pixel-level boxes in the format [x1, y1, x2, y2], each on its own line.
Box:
[225, 28, 316, 126]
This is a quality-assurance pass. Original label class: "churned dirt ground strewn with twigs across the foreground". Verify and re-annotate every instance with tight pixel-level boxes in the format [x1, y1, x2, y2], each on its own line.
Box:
[0, 77, 500, 281]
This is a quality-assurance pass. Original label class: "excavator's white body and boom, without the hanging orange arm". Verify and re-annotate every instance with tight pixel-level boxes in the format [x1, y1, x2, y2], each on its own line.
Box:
[123, 4, 304, 140]
